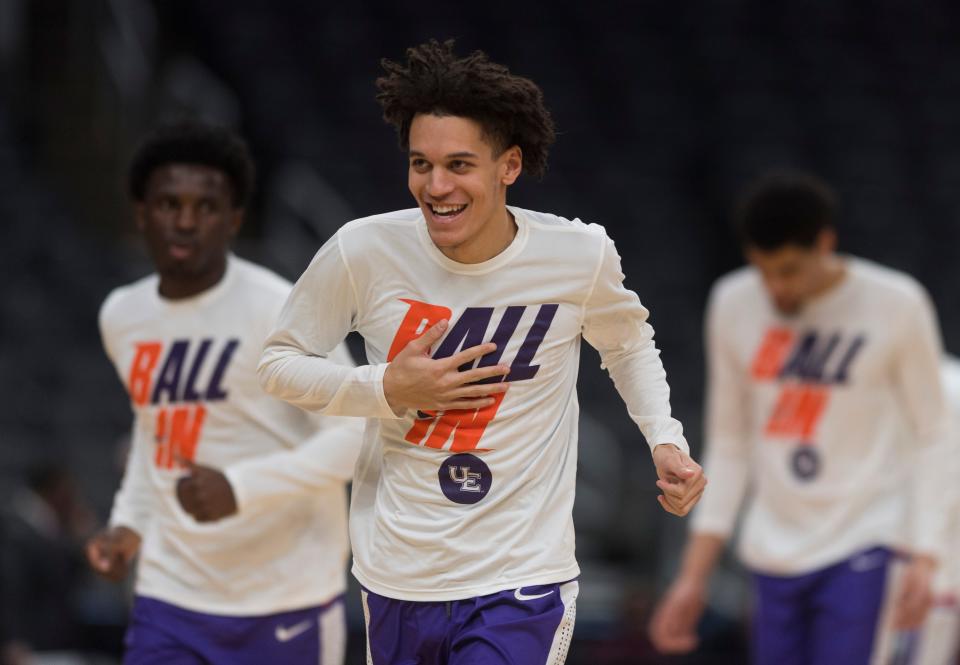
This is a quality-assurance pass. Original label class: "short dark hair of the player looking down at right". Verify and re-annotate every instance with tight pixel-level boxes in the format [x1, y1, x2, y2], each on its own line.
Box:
[734, 170, 837, 251]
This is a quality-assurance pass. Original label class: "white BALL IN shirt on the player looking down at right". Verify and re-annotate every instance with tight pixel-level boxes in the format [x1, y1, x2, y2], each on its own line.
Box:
[692, 257, 950, 575]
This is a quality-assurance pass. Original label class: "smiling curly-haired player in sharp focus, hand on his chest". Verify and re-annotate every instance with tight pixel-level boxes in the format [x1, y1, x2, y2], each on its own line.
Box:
[260, 41, 705, 665]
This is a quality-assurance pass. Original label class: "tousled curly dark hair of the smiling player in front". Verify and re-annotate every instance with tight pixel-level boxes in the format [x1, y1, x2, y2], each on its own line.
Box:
[376, 39, 556, 178]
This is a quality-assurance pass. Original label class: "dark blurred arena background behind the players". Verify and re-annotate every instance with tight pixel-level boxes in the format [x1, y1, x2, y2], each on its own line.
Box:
[0, 0, 960, 665]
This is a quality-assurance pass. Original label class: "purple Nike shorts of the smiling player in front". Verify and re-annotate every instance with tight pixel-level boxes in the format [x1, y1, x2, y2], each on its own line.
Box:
[362, 581, 580, 665]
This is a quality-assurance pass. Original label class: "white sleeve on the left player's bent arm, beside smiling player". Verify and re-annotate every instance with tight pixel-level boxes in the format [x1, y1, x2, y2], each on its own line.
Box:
[224, 344, 366, 512]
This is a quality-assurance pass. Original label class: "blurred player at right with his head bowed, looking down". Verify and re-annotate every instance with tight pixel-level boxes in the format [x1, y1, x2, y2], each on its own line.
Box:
[650, 172, 950, 665]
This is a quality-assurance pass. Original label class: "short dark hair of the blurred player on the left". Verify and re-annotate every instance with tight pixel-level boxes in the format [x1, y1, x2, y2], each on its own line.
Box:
[128, 120, 256, 208]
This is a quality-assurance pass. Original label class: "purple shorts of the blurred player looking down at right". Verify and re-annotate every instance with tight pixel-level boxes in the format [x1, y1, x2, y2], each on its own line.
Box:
[753, 547, 893, 665]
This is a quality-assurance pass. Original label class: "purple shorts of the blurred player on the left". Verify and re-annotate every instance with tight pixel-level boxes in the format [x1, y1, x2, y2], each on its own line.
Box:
[123, 596, 346, 665]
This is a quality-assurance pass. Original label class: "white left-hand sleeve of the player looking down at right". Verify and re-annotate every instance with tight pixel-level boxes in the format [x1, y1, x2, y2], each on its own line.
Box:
[691, 290, 750, 538]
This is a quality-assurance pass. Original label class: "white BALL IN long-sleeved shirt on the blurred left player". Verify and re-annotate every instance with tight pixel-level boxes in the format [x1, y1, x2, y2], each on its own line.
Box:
[100, 256, 362, 616]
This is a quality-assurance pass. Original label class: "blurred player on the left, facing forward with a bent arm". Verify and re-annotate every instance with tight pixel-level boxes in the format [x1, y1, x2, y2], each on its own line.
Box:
[88, 123, 361, 665]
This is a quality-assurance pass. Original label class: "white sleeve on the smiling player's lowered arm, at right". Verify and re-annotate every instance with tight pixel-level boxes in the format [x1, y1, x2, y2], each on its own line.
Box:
[582, 231, 690, 452]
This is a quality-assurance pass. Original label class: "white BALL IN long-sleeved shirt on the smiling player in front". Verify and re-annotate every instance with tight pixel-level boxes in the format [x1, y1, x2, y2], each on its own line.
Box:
[260, 207, 687, 601]
